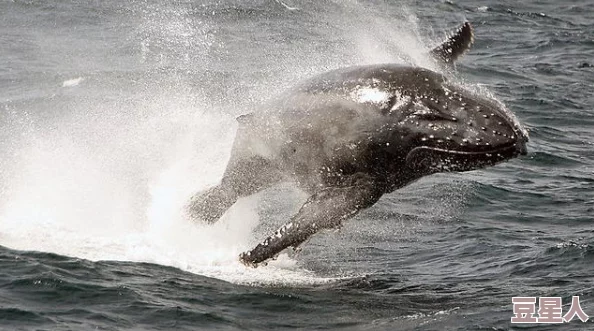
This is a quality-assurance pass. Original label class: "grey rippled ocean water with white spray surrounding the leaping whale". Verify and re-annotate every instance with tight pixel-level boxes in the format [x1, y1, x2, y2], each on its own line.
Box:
[0, 0, 594, 330]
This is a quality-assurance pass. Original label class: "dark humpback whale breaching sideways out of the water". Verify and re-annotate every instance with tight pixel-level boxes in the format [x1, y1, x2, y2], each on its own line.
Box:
[186, 22, 528, 267]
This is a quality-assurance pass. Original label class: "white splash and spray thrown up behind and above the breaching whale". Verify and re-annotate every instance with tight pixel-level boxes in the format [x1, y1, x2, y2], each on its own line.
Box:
[0, 2, 464, 283]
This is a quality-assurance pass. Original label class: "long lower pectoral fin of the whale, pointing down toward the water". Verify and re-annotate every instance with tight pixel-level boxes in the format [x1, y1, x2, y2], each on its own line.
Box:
[239, 181, 381, 267]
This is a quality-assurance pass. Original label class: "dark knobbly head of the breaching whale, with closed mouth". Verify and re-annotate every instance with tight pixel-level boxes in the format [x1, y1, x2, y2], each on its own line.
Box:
[389, 69, 528, 175]
